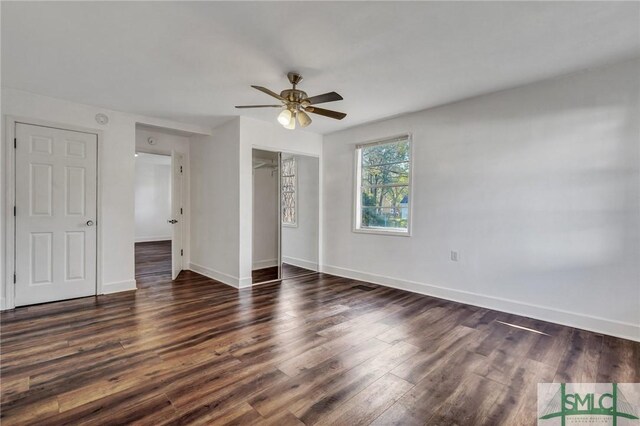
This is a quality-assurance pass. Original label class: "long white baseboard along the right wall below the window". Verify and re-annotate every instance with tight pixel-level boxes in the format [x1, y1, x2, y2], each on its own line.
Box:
[322, 265, 640, 342]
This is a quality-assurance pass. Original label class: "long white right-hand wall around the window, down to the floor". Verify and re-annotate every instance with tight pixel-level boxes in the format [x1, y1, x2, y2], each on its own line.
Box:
[323, 60, 640, 340]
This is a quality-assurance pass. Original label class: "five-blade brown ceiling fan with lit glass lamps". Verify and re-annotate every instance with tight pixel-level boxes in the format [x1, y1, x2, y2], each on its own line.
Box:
[236, 72, 347, 129]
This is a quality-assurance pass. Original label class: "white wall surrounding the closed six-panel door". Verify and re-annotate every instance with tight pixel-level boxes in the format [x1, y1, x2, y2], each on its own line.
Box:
[0, 88, 209, 307]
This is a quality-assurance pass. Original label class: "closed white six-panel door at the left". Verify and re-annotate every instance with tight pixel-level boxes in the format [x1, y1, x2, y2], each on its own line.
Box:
[15, 124, 98, 306]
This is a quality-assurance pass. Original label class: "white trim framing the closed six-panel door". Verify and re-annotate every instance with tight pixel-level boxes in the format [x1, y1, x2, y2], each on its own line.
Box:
[0, 115, 103, 310]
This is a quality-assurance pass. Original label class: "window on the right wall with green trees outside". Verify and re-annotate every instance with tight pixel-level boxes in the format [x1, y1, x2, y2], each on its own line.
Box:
[355, 135, 411, 235]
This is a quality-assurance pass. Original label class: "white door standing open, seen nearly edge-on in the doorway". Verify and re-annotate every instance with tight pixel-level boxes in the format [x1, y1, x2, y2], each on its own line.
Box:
[169, 151, 184, 280]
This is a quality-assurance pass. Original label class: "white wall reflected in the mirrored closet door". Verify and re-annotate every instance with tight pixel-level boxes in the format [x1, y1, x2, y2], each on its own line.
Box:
[282, 155, 320, 271]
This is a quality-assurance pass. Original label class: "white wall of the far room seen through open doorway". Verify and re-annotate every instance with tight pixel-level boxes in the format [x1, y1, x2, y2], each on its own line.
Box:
[135, 154, 172, 242]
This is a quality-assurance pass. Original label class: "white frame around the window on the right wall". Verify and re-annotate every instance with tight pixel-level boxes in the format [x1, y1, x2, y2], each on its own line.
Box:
[352, 133, 413, 237]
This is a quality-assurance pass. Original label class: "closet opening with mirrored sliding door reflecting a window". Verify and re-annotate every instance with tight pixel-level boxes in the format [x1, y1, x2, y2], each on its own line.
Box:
[251, 149, 320, 284]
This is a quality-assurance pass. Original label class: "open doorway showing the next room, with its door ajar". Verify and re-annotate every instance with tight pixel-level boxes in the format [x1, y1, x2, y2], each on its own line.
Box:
[135, 152, 182, 286]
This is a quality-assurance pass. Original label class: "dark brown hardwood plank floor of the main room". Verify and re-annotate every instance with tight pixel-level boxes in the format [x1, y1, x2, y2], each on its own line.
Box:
[0, 271, 640, 426]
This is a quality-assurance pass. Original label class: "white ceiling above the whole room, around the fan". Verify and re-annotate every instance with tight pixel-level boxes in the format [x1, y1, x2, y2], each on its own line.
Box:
[1, 1, 640, 133]
